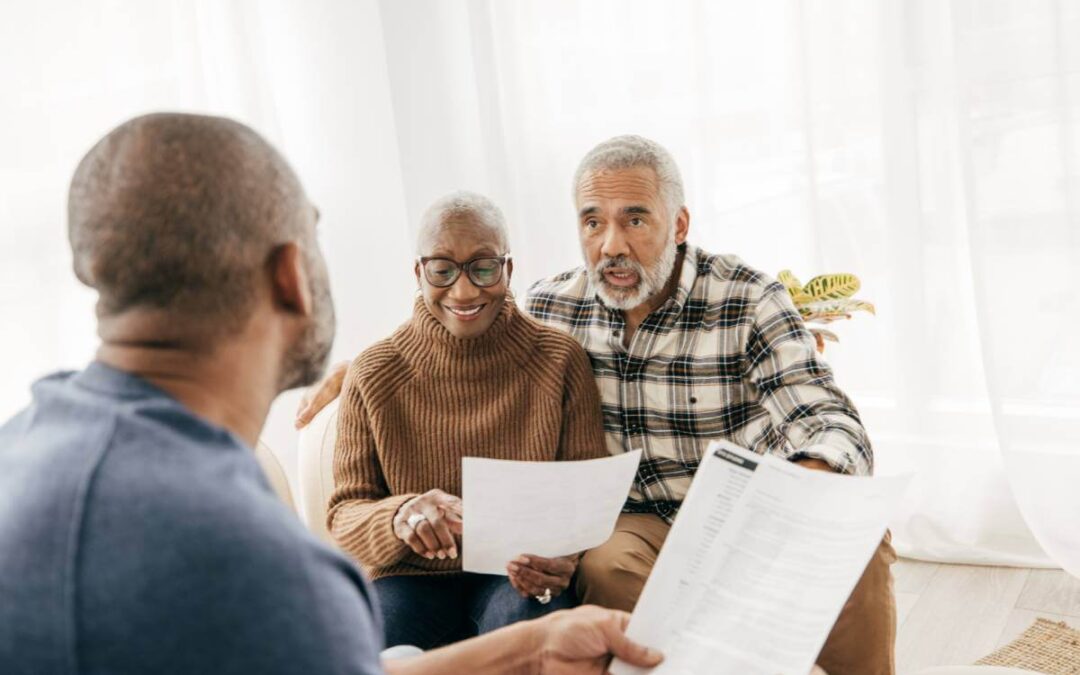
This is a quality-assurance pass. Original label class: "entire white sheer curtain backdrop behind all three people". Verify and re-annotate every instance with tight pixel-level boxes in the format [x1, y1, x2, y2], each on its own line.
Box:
[0, 0, 1080, 573]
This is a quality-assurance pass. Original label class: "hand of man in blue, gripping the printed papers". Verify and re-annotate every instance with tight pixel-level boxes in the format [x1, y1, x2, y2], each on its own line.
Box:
[537, 605, 663, 675]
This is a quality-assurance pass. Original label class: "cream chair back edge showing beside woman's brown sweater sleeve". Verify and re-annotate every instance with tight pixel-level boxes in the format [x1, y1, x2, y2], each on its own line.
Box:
[298, 400, 338, 543]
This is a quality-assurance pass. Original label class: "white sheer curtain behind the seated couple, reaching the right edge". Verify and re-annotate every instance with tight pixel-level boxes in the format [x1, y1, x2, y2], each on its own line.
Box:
[380, 0, 1080, 573]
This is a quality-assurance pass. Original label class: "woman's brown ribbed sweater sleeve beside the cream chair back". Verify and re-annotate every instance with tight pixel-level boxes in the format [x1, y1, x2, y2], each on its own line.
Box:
[327, 360, 416, 567]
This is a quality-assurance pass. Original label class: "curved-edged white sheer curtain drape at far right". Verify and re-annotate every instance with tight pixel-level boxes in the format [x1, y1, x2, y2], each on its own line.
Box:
[955, 0, 1080, 577]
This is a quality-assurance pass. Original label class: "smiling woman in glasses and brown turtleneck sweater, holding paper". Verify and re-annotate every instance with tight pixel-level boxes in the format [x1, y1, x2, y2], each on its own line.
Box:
[328, 192, 605, 649]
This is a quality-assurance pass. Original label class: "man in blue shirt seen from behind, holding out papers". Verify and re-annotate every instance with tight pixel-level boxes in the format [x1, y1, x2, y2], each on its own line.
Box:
[0, 114, 659, 675]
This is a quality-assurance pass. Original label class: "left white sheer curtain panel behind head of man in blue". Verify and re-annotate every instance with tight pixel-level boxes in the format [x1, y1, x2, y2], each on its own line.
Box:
[0, 0, 413, 488]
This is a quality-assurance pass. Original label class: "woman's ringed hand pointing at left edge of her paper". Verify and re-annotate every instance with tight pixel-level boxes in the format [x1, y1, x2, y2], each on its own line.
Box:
[393, 489, 461, 561]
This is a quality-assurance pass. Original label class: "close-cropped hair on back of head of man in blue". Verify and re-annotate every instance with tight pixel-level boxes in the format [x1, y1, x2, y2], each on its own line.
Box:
[68, 113, 312, 327]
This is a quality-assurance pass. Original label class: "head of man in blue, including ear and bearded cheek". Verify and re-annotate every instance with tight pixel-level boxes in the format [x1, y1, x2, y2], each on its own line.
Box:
[68, 113, 335, 391]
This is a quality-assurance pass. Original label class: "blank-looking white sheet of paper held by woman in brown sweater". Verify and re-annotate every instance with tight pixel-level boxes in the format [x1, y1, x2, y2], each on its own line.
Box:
[461, 450, 642, 575]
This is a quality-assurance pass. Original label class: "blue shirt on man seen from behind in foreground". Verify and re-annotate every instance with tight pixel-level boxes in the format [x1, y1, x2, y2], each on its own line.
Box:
[0, 363, 382, 675]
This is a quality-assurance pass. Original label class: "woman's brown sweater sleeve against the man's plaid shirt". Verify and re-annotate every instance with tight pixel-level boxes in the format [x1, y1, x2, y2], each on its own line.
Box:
[557, 342, 607, 460]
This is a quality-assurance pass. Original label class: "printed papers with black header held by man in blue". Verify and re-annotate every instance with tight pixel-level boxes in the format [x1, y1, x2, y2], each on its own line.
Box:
[611, 443, 909, 675]
